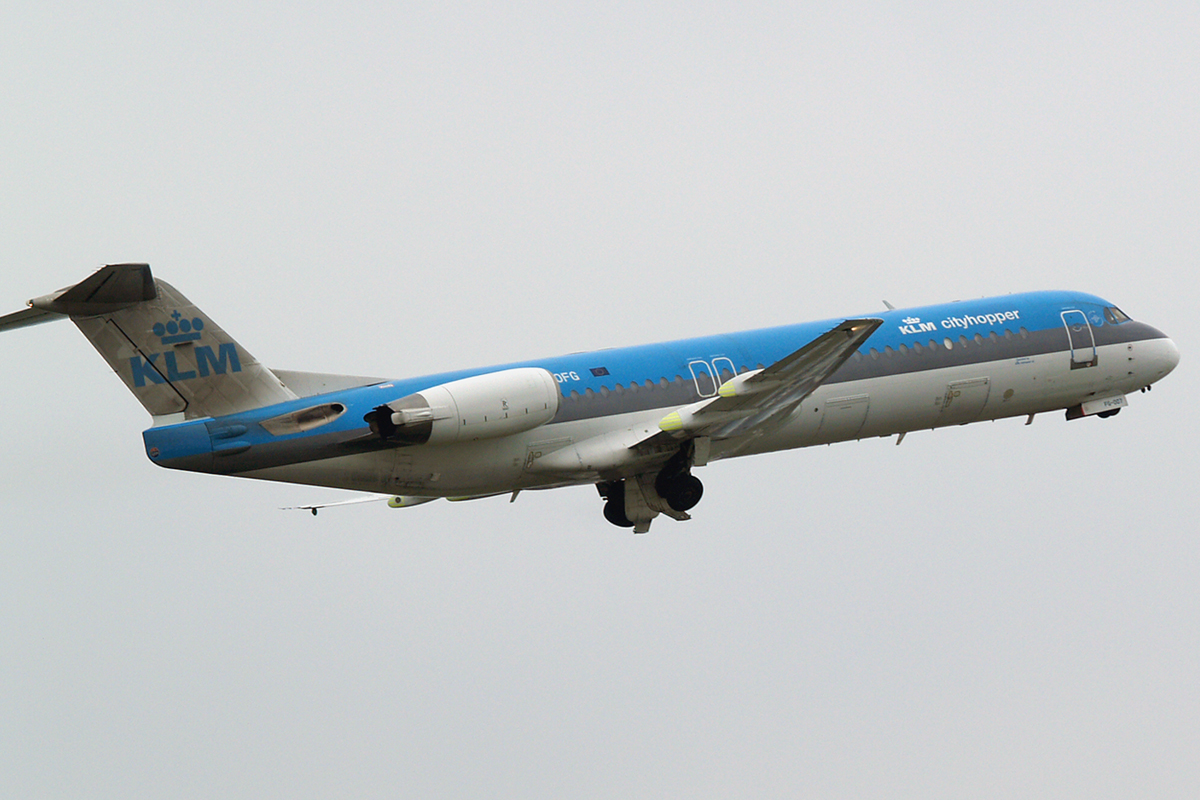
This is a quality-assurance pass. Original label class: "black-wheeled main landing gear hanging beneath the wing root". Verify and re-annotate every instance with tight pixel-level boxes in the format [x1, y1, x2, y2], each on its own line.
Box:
[596, 443, 704, 534]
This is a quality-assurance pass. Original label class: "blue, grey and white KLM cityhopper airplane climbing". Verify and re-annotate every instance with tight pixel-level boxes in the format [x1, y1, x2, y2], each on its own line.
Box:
[0, 264, 1180, 533]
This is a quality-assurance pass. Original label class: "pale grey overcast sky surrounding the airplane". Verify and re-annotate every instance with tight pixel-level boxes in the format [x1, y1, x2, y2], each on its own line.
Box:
[0, 0, 1200, 799]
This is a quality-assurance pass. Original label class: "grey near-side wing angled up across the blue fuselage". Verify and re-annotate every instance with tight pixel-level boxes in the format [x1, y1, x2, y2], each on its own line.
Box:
[637, 319, 883, 446]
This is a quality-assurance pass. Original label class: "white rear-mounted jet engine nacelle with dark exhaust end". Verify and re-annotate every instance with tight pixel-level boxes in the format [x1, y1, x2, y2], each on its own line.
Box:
[362, 367, 562, 445]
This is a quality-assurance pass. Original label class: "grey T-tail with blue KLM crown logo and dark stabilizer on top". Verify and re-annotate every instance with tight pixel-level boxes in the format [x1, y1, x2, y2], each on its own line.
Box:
[0, 264, 296, 419]
